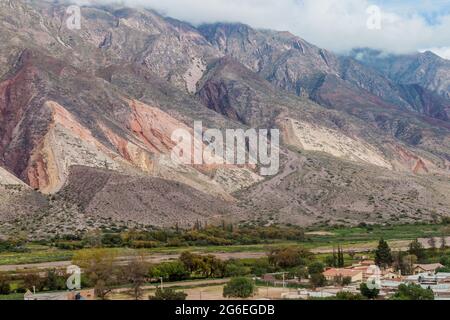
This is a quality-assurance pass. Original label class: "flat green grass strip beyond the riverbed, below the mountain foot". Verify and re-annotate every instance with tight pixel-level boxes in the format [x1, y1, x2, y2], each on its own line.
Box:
[0, 224, 450, 265]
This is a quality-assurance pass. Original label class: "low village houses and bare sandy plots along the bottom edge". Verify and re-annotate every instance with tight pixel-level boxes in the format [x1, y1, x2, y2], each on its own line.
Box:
[24, 249, 450, 300]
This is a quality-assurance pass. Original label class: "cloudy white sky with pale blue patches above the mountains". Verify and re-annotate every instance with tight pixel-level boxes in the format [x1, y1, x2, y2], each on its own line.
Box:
[78, 0, 450, 59]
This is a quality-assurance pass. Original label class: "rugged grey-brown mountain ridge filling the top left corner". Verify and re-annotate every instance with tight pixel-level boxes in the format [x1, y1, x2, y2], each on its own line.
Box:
[0, 0, 221, 91]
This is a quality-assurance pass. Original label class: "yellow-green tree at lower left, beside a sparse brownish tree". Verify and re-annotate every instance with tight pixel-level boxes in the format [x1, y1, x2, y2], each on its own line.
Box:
[73, 249, 116, 300]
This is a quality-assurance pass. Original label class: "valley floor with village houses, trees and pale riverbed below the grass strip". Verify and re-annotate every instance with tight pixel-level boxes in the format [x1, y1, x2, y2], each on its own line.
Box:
[5, 224, 450, 300]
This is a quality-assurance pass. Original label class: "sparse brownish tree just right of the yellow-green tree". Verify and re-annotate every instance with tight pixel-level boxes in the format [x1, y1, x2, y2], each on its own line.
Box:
[121, 256, 149, 300]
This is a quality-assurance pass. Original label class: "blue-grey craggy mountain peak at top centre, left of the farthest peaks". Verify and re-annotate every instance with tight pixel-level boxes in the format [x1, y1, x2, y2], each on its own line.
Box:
[199, 23, 339, 95]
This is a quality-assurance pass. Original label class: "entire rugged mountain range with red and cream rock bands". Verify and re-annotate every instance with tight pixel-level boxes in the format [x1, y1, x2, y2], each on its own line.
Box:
[0, 0, 450, 237]
